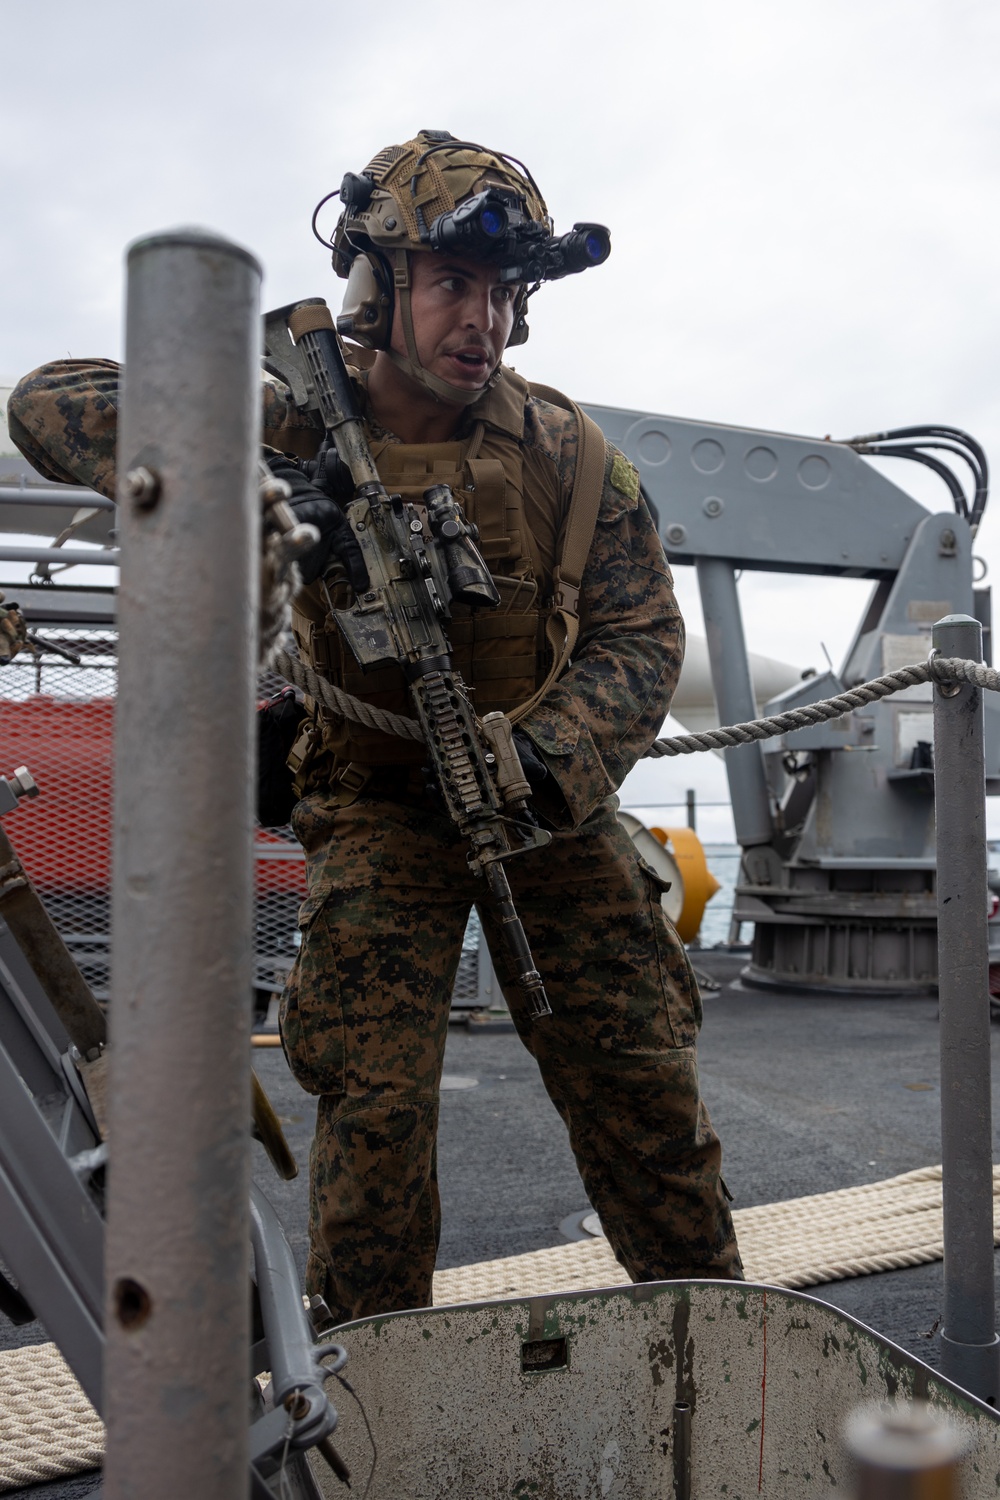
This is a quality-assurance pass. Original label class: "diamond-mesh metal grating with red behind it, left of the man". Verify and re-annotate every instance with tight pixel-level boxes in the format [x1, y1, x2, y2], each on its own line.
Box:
[0, 626, 489, 1010]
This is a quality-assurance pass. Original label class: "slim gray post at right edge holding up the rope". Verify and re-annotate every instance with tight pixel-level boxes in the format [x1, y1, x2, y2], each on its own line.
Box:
[933, 615, 1000, 1403]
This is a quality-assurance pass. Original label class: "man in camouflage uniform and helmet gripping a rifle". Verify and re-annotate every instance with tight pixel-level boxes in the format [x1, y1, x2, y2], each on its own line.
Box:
[9, 131, 742, 1322]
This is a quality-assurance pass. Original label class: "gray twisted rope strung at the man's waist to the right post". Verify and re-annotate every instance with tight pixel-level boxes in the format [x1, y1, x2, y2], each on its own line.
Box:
[274, 651, 1000, 759]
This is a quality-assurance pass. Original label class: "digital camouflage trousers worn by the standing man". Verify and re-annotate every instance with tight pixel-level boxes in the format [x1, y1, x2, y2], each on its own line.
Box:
[282, 794, 742, 1322]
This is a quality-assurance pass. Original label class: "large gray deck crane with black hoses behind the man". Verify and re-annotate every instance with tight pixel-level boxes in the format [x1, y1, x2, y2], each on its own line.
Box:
[589, 407, 1000, 995]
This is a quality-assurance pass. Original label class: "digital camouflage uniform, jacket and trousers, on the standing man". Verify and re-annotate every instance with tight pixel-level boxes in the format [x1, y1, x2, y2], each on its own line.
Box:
[9, 362, 742, 1319]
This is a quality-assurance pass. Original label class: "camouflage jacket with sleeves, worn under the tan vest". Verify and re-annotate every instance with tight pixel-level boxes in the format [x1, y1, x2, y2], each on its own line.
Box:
[7, 360, 684, 827]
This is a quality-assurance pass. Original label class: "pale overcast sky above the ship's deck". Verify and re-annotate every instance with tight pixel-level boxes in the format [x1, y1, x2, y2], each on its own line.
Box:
[0, 0, 1000, 836]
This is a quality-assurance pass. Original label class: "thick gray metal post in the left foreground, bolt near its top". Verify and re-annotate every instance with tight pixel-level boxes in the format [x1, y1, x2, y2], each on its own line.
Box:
[103, 230, 261, 1500]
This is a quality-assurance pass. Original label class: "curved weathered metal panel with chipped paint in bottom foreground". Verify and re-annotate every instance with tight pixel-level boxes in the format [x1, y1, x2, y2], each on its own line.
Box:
[313, 1281, 1000, 1500]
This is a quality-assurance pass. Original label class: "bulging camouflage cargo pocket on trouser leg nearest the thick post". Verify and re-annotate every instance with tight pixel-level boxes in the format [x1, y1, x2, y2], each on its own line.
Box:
[280, 896, 346, 1094]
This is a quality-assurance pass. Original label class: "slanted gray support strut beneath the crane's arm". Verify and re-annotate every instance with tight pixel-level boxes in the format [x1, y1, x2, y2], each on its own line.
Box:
[694, 558, 774, 849]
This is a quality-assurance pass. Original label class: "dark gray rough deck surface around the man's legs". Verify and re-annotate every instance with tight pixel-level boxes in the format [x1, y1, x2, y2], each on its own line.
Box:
[7, 951, 1000, 1500]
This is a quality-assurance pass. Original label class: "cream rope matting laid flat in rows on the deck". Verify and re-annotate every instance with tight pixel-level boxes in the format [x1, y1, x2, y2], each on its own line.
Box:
[0, 1167, 1000, 1491]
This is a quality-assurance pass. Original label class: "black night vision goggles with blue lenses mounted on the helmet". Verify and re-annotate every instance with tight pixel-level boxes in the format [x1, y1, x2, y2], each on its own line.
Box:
[427, 188, 612, 282]
